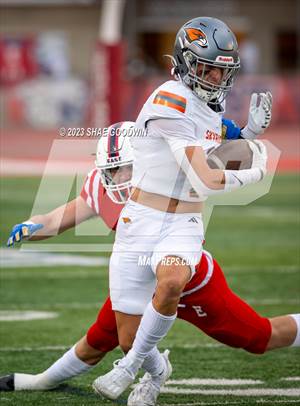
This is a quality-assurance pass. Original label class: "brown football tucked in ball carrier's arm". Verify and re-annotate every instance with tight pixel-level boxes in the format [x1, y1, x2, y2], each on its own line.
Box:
[207, 139, 255, 170]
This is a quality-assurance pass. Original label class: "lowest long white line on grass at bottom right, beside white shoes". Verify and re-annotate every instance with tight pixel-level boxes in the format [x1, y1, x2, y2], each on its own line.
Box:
[161, 387, 300, 397]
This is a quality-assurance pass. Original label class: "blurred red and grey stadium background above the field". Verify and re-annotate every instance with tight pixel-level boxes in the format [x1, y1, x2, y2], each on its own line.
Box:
[0, 0, 300, 174]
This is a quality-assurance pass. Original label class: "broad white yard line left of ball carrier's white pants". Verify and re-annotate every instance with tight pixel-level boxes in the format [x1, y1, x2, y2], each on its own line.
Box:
[0, 248, 109, 268]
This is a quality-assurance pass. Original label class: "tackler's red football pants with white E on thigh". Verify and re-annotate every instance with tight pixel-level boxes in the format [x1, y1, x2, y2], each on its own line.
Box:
[87, 260, 271, 354]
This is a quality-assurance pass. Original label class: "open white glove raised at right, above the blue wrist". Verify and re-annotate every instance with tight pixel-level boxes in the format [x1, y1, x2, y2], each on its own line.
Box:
[242, 92, 273, 139]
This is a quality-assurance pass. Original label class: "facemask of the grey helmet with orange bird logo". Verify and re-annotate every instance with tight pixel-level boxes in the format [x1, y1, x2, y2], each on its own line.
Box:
[182, 50, 239, 104]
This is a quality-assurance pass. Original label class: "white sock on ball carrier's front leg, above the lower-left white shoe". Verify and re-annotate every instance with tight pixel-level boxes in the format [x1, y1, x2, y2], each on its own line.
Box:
[119, 302, 177, 375]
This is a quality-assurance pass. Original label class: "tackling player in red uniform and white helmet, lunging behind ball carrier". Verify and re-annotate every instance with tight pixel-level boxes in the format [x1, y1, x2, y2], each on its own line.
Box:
[0, 122, 300, 405]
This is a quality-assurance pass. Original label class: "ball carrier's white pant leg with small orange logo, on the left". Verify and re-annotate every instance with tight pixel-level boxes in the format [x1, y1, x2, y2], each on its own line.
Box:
[109, 202, 170, 315]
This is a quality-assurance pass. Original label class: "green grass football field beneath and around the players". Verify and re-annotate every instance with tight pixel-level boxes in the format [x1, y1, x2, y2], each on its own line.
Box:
[0, 175, 300, 406]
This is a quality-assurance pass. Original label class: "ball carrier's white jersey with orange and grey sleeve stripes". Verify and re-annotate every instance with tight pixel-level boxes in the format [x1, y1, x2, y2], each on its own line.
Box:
[131, 80, 223, 202]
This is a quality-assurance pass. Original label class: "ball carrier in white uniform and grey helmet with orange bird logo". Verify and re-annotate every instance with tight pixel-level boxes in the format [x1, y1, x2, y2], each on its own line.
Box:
[93, 17, 271, 399]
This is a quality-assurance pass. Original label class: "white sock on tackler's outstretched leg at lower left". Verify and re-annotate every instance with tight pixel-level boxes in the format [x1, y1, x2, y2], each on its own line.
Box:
[14, 345, 93, 390]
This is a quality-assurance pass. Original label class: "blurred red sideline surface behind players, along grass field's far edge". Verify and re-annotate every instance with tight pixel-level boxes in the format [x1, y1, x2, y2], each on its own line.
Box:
[0, 127, 300, 176]
